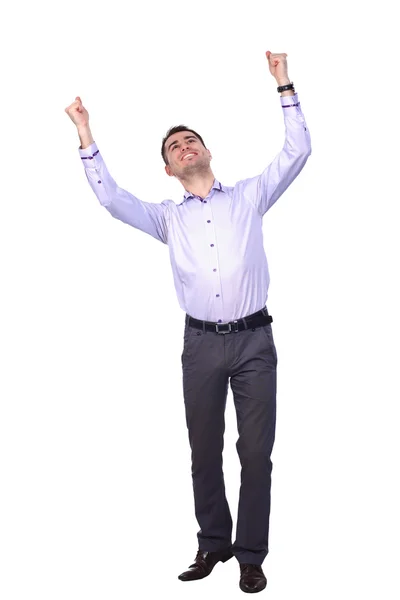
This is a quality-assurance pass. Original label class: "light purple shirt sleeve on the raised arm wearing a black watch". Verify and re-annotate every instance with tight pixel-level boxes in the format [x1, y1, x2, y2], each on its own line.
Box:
[235, 94, 311, 216]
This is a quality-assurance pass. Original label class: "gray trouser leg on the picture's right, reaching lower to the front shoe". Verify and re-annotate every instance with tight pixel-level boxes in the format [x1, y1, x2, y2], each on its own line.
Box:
[231, 325, 277, 565]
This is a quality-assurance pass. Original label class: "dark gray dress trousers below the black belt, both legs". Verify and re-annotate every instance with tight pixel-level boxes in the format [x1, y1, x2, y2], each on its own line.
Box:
[182, 308, 277, 565]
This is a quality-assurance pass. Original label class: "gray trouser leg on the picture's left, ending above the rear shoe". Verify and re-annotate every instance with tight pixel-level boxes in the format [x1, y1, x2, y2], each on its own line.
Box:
[182, 329, 232, 552]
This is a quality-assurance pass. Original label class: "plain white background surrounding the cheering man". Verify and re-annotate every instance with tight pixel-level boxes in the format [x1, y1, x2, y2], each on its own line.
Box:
[0, 0, 400, 600]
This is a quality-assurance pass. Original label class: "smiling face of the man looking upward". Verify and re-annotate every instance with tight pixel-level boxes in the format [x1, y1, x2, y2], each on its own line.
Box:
[164, 131, 211, 178]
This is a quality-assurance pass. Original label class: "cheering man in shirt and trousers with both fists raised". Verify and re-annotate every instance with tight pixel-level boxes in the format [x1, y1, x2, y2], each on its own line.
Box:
[65, 51, 311, 592]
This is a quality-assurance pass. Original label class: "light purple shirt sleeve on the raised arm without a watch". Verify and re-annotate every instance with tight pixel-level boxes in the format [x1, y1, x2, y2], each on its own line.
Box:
[79, 142, 170, 244]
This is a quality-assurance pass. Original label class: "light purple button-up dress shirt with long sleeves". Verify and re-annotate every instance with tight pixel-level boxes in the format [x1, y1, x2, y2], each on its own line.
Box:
[79, 94, 311, 323]
